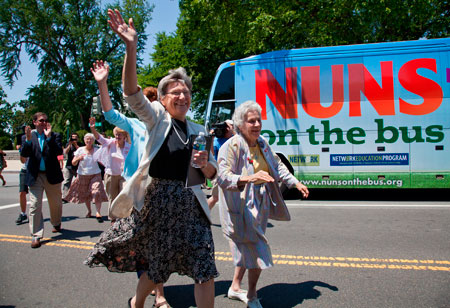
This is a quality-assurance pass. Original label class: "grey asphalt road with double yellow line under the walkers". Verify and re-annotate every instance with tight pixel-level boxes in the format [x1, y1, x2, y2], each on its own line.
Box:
[0, 174, 450, 308]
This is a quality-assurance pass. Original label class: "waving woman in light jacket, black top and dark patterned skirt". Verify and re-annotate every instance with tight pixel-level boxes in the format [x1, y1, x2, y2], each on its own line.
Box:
[85, 10, 218, 308]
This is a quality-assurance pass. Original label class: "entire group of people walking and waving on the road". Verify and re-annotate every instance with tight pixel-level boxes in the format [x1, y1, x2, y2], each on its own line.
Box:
[7, 10, 309, 308]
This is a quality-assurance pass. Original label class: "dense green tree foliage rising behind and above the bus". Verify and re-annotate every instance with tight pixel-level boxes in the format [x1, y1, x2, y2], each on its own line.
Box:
[170, 0, 450, 117]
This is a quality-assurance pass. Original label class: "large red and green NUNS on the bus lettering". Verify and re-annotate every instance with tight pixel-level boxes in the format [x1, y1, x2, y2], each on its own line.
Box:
[255, 58, 444, 145]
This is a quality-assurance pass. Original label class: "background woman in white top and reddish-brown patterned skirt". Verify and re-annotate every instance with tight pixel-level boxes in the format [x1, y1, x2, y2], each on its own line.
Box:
[66, 133, 108, 222]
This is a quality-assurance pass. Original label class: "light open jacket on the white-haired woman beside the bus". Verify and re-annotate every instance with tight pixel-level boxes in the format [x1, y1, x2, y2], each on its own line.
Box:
[217, 134, 298, 243]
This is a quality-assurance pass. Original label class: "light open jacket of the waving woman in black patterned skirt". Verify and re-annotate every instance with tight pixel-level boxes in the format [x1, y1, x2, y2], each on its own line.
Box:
[111, 88, 217, 222]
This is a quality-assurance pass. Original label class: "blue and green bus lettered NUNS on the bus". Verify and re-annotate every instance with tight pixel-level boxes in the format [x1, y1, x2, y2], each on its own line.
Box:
[205, 38, 450, 189]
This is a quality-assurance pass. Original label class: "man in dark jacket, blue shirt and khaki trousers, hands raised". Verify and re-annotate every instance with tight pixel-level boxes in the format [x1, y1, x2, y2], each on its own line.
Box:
[20, 112, 63, 248]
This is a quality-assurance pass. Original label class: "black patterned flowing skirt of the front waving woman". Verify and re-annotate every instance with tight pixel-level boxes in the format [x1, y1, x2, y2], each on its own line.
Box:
[84, 179, 219, 283]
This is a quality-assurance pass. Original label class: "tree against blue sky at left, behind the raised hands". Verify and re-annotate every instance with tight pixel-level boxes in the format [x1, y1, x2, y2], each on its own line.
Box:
[0, 0, 153, 131]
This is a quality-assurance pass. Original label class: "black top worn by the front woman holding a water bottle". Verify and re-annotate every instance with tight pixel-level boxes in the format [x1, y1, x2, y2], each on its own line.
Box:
[148, 119, 191, 182]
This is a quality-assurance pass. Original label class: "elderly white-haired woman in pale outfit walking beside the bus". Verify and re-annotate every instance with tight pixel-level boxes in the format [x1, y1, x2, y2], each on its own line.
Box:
[217, 101, 309, 308]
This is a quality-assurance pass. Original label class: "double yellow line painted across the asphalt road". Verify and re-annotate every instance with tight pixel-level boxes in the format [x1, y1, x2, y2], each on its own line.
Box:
[0, 234, 450, 272]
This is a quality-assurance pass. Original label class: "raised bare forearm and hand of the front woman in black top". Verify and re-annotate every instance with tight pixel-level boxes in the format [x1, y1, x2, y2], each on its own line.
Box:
[108, 9, 139, 96]
